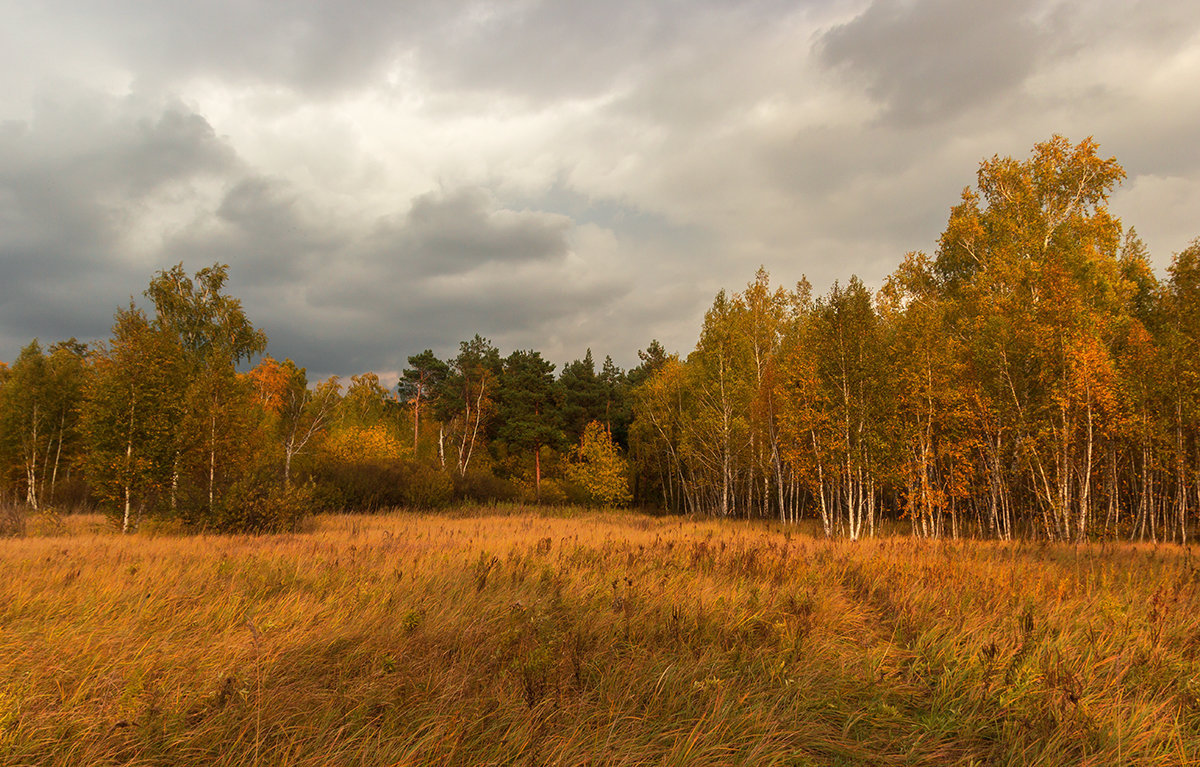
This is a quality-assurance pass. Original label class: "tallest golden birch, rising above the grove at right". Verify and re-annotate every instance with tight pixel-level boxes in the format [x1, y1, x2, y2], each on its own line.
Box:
[935, 136, 1124, 539]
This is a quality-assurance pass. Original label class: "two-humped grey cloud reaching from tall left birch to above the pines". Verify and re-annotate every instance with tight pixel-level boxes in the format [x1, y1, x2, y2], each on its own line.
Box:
[148, 178, 629, 376]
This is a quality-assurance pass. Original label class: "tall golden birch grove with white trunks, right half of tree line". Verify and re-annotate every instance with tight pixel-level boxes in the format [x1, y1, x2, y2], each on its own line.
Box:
[632, 137, 1200, 541]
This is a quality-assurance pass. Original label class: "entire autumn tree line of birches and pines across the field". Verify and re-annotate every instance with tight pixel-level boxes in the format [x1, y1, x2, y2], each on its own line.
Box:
[0, 137, 1200, 541]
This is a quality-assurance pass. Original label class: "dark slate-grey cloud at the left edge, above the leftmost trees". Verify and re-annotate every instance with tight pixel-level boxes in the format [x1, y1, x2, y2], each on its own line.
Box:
[0, 93, 236, 349]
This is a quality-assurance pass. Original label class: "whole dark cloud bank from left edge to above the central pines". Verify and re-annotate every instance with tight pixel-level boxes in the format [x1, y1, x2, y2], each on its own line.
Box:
[0, 83, 643, 372]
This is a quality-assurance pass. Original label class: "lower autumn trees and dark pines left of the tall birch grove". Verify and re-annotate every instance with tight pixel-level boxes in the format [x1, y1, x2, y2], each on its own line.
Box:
[0, 264, 648, 531]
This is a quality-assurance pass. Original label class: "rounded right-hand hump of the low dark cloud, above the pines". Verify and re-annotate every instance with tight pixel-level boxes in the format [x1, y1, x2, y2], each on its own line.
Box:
[264, 188, 629, 370]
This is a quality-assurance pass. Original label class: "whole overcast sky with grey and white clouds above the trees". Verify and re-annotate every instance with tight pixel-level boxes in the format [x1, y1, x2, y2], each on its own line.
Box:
[0, 0, 1200, 380]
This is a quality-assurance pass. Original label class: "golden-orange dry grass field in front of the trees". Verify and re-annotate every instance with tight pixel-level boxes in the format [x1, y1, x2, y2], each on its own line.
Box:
[0, 509, 1200, 765]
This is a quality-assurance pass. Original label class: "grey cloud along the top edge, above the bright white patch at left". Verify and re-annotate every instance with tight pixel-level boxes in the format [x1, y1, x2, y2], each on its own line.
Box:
[25, 0, 451, 96]
